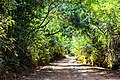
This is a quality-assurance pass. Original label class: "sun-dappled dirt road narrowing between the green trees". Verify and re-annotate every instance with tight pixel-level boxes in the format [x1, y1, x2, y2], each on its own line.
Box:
[16, 56, 120, 80]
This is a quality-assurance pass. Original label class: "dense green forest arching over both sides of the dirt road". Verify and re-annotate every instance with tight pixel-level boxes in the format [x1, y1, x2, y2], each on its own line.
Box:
[0, 0, 120, 79]
